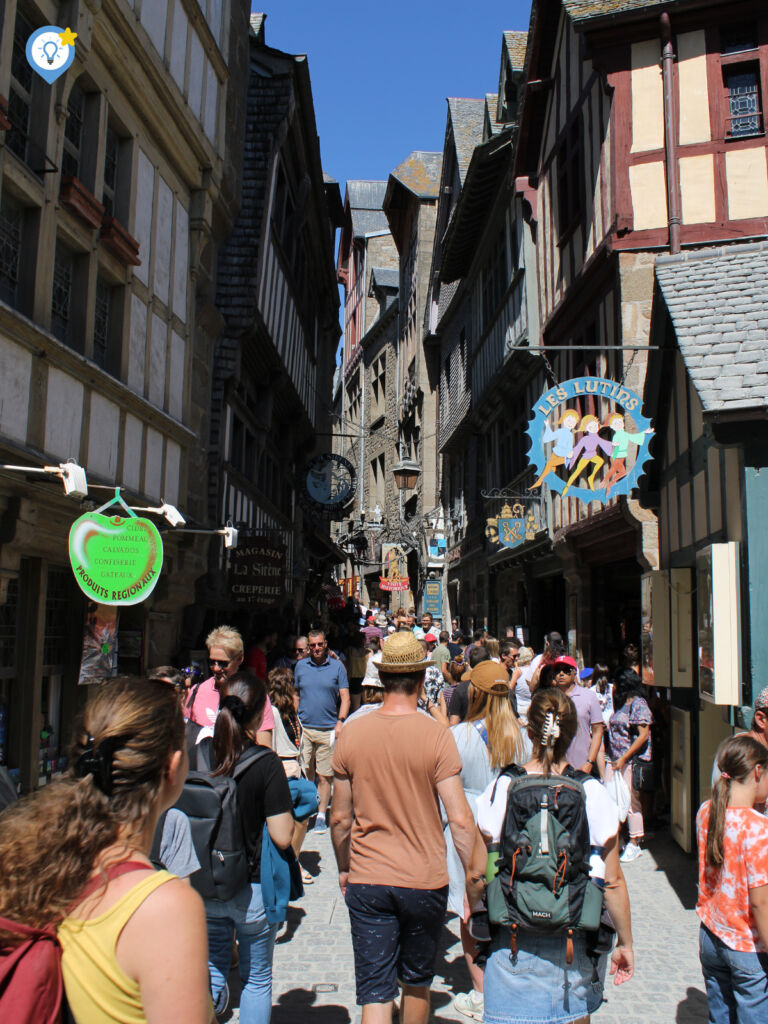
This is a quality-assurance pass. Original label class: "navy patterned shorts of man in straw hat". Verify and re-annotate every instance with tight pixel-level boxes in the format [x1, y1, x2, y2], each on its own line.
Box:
[346, 883, 447, 1007]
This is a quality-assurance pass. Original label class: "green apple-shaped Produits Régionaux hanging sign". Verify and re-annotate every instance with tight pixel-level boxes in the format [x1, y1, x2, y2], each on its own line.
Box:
[70, 512, 163, 604]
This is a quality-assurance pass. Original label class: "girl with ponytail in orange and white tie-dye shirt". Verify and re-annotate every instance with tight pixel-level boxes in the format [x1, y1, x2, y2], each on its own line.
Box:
[696, 734, 768, 1024]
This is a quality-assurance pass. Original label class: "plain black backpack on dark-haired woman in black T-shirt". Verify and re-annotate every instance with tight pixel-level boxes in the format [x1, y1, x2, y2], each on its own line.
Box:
[176, 746, 271, 900]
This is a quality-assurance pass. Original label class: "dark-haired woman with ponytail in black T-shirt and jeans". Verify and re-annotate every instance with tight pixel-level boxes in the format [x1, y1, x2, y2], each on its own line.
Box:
[206, 672, 294, 1024]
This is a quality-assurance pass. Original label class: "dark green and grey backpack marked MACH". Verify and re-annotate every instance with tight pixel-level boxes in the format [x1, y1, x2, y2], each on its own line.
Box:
[487, 765, 602, 963]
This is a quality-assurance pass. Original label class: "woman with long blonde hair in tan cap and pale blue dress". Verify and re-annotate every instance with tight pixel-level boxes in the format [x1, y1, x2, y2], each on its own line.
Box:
[445, 662, 530, 1020]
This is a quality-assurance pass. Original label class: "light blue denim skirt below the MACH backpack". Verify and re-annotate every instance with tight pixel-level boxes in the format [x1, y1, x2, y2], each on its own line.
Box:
[482, 929, 606, 1024]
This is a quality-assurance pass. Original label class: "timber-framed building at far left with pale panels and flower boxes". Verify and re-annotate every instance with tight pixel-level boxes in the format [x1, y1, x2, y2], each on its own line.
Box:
[0, 0, 248, 790]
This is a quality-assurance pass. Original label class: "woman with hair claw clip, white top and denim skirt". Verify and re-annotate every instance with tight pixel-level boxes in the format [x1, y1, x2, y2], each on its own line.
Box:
[467, 687, 634, 1024]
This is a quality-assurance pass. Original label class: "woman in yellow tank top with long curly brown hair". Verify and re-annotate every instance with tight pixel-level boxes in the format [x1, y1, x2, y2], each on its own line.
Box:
[0, 678, 213, 1024]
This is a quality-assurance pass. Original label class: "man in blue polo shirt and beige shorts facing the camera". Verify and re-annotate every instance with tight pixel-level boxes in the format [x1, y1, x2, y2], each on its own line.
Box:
[294, 630, 349, 831]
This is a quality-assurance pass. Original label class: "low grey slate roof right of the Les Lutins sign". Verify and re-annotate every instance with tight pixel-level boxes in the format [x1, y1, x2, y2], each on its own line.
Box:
[655, 242, 768, 413]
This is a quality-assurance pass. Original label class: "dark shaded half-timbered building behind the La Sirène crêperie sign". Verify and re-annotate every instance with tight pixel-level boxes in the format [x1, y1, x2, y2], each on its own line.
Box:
[205, 15, 342, 635]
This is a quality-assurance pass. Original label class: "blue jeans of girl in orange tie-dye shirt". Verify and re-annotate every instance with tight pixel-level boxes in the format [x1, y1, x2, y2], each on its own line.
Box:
[698, 925, 768, 1024]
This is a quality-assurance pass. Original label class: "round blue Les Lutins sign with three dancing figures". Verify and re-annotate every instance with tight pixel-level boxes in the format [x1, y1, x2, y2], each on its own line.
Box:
[527, 377, 653, 504]
